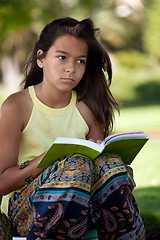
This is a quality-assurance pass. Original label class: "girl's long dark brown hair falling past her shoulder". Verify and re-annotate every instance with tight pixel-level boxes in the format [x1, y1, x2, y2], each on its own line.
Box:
[23, 17, 119, 136]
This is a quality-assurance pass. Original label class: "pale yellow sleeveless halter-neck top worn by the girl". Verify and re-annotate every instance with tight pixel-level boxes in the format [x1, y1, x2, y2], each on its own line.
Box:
[18, 86, 89, 164]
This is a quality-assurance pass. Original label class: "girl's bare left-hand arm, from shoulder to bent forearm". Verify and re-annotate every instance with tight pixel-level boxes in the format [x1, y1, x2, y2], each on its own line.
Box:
[0, 94, 44, 195]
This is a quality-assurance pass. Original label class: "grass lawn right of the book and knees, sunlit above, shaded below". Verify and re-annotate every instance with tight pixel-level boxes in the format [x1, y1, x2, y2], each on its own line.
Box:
[114, 105, 160, 229]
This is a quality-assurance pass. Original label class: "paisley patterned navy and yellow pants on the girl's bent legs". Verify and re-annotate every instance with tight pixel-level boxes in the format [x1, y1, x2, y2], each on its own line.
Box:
[9, 153, 145, 240]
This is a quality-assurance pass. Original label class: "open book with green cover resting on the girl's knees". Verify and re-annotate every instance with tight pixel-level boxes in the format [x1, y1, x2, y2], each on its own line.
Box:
[37, 131, 148, 168]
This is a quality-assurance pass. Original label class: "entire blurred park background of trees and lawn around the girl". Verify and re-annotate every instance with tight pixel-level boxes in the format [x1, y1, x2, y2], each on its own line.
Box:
[0, 0, 160, 236]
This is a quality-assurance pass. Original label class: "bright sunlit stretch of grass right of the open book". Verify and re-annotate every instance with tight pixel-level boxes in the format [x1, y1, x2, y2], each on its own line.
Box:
[114, 105, 160, 187]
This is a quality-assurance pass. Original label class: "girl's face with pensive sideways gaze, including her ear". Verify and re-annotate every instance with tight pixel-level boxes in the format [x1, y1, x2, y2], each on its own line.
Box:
[37, 35, 88, 91]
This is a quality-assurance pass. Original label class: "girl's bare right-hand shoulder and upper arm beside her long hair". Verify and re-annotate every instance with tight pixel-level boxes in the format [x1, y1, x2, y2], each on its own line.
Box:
[77, 101, 104, 141]
